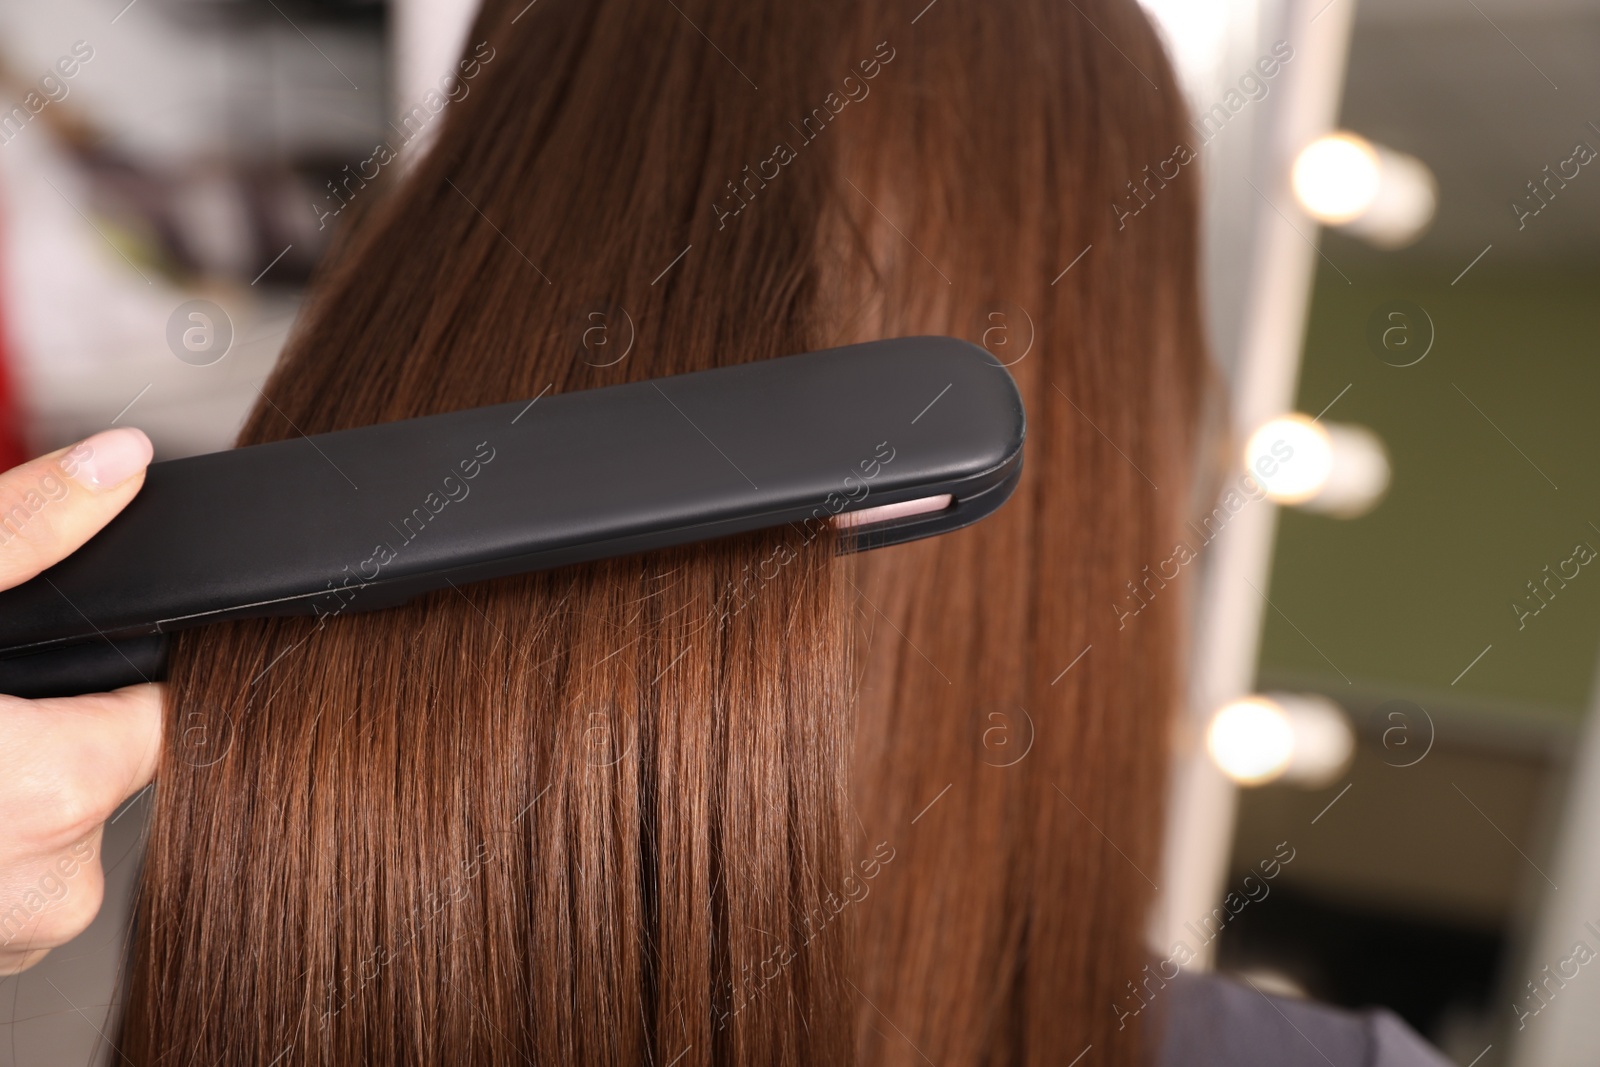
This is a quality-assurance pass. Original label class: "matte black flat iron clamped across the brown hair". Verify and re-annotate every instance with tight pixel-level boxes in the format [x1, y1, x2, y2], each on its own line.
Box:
[0, 338, 1026, 697]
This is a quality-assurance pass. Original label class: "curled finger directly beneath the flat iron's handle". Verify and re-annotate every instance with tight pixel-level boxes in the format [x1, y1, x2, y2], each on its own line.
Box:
[0, 683, 163, 865]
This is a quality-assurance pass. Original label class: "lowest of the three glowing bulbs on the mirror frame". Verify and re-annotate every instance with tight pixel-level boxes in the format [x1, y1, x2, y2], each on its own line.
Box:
[1206, 693, 1355, 789]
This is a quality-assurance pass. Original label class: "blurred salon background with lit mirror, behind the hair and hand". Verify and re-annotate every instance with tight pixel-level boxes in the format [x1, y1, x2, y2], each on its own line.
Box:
[0, 0, 1600, 1067]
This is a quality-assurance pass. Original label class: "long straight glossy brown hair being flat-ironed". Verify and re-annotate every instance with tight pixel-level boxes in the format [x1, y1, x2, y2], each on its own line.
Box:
[120, 0, 1205, 1067]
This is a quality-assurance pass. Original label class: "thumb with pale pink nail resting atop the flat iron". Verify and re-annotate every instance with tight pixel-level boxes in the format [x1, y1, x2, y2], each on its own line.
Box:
[0, 427, 150, 589]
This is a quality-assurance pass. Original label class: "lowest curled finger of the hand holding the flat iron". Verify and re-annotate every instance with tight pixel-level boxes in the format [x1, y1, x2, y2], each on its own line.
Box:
[0, 827, 106, 974]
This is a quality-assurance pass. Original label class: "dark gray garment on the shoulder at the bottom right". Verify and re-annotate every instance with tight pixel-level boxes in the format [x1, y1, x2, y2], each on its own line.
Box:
[1157, 973, 1451, 1067]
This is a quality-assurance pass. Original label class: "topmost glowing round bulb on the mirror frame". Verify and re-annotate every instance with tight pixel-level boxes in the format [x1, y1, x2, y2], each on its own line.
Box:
[1290, 133, 1438, 248]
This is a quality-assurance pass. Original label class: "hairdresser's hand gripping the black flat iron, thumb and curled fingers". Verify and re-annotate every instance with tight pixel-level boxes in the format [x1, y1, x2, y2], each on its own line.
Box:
[0, 429, 162, 974]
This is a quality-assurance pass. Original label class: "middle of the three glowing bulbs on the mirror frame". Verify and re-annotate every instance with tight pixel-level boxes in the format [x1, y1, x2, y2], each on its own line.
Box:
[1245, 413, 1390, 518]
